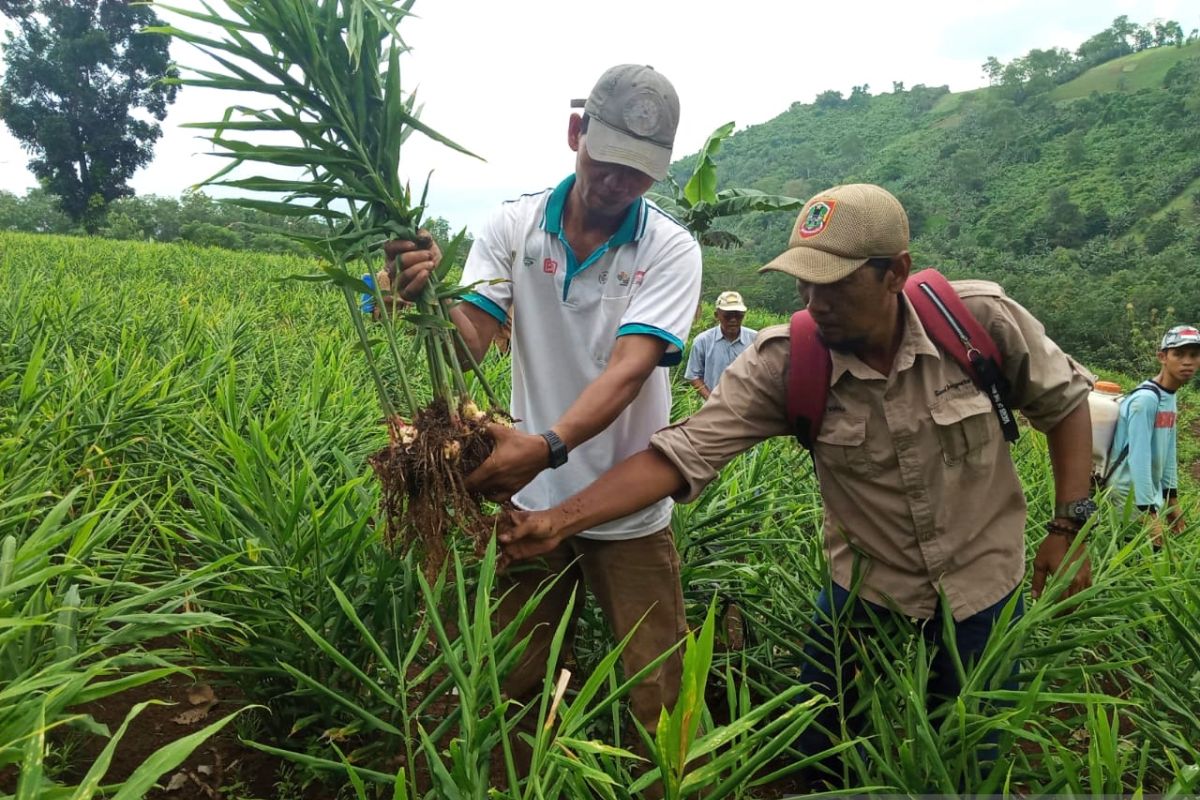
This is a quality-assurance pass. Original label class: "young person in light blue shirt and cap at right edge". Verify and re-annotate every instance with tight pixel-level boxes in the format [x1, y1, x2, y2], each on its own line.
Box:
[1109, 325, 1200, 549]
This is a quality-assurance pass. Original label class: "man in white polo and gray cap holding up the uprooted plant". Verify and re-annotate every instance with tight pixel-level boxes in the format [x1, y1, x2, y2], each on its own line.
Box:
[388, 65, 701, 762]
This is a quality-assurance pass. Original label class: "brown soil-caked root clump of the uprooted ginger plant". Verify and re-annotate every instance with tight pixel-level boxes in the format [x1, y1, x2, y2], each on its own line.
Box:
[371, 401, 511, 577]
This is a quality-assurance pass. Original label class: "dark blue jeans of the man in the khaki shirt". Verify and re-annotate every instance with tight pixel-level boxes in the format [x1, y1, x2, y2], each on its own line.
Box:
[799, 583, 1025, 767]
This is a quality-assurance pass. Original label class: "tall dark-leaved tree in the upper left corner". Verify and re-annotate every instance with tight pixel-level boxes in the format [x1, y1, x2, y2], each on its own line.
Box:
[0, 0, 176, 230]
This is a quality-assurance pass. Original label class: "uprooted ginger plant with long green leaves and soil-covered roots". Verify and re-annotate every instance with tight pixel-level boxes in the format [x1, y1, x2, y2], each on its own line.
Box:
[154, 0, 509, 572]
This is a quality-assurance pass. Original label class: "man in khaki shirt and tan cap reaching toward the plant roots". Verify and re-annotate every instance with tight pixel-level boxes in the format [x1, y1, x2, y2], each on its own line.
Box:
[499, 185, 1094, 777]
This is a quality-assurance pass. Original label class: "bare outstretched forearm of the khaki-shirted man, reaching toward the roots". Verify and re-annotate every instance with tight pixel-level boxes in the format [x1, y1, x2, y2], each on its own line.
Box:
[550, 447, 686, 537]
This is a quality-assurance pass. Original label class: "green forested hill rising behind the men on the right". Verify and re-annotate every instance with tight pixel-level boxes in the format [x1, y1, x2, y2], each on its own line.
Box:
[674, 24, 1200, 372]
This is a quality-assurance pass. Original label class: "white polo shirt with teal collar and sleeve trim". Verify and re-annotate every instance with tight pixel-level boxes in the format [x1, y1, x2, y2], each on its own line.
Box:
[462, 174, 701, 539]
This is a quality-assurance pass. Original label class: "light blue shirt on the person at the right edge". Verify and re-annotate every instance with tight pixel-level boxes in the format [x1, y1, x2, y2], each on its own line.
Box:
[1109, 380, 1178, 510]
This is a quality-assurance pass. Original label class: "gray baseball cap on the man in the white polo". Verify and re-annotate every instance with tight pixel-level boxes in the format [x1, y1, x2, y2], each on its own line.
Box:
[572, 64, 679, 181]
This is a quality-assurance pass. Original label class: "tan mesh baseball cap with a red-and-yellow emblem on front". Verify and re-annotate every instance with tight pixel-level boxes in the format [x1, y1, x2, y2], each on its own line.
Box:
[758, 184, 908, 283]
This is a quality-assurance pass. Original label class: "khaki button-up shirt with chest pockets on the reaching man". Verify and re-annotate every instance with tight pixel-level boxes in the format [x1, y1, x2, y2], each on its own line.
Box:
[650, 281, 1088, 620]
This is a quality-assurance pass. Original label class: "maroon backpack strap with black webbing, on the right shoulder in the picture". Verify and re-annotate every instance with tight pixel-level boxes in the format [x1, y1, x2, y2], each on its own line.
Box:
[904, 270, 1020, 441]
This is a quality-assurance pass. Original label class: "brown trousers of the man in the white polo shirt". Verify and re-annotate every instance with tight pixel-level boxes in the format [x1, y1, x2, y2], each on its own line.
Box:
[497, 528, 688, 762]
